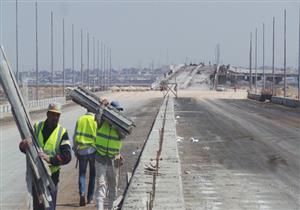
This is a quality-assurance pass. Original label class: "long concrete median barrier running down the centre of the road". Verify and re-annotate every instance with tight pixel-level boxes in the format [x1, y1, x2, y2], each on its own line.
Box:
[122, 98, 185, 210]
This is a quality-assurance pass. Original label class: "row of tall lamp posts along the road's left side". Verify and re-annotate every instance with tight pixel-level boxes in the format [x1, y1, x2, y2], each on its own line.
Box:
[15, 0, 111, 100]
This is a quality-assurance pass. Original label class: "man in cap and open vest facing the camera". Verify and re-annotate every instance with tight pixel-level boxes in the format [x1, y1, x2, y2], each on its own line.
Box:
[19, 103, 71, 210]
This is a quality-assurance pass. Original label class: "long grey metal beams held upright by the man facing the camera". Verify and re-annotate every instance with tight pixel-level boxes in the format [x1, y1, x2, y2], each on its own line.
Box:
[0, 46, 55, 209]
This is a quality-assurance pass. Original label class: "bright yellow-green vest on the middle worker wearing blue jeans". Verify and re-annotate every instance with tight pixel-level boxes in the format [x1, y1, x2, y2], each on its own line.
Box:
[74, 113, 97, 150]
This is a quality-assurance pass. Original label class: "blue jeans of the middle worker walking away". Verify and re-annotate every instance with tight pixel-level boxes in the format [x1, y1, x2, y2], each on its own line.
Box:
[78, 154, 95, 201]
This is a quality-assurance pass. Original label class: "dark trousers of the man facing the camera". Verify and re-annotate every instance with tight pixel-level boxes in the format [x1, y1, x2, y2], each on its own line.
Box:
[32, 171, 59, 210]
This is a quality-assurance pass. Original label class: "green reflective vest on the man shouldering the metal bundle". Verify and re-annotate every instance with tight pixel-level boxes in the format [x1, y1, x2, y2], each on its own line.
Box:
[96, 121, 122, 158]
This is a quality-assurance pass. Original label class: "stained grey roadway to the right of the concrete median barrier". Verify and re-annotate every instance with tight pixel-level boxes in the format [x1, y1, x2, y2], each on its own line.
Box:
[175, 97, 300, 210]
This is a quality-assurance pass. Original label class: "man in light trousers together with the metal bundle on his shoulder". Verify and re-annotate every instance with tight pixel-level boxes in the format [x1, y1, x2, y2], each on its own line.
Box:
[69, 87, 135, 210]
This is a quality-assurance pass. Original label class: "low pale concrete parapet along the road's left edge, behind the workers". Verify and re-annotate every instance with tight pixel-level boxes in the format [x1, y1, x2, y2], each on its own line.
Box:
[0, 97, 66, 118]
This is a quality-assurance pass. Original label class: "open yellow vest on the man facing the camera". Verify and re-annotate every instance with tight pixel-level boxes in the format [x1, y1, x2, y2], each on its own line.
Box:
[34, 121, 66, 174]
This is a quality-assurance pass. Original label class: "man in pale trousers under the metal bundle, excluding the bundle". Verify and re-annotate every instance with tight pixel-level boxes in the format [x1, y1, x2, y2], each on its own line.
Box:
[95, 99, 125, 210]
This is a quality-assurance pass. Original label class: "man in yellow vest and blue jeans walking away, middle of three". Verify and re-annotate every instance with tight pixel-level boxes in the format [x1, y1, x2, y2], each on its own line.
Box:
[73, 111, 97, 206]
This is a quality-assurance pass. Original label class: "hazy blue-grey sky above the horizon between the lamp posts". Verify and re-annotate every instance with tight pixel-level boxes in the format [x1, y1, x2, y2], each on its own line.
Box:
[0, 0, 299, 71]
